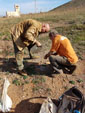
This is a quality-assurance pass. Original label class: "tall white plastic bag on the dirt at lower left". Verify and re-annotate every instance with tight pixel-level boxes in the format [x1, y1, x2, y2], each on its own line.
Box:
[0, 78, 12, 112]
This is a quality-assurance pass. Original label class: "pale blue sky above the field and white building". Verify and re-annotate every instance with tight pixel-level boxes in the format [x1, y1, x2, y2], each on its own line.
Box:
[0, 0, 71, 16]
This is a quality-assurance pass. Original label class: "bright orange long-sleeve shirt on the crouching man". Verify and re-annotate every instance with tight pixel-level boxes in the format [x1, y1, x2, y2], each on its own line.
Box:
[50, 35, 78, 64]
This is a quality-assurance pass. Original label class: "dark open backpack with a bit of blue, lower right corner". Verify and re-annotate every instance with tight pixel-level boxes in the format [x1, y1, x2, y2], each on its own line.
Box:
[57, 86, 85, 113]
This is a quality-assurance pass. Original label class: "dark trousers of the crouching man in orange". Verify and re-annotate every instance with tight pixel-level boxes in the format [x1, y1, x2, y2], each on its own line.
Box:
[49, 55, 76, 73]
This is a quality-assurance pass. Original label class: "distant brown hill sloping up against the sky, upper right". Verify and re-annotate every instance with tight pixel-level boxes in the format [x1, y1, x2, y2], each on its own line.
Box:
[51, 0, 85, 11]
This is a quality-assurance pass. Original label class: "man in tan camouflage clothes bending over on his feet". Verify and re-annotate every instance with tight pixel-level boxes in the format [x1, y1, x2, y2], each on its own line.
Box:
[11, 19, 50, 75]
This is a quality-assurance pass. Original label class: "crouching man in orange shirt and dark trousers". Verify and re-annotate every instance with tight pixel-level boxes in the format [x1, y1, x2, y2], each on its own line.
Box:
[44, 31, 78, 74]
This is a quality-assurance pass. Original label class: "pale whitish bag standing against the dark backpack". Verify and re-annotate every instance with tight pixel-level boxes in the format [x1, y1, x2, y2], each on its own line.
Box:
[39, 97, 57, 113]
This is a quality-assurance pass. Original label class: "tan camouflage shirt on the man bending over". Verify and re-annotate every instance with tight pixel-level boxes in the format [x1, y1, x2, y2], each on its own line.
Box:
[11, 19, 42, 50]
